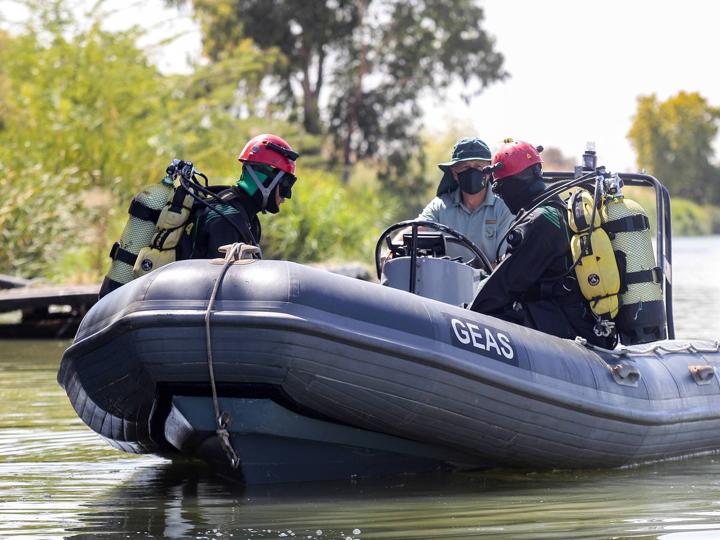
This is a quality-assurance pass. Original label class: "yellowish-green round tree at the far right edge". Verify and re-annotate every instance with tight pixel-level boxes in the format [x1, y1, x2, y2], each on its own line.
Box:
[628, 92, 720, 204]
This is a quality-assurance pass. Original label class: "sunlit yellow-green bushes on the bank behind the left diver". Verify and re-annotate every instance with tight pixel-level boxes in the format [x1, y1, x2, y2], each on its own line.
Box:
[0, 4, 387, 282]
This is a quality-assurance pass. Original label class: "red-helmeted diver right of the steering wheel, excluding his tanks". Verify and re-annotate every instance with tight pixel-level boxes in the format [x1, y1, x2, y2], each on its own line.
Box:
[470, 139, 617, 349]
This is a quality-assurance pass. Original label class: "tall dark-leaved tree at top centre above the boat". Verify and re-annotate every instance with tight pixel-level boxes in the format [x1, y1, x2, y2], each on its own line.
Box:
[167, 0, 506, 209]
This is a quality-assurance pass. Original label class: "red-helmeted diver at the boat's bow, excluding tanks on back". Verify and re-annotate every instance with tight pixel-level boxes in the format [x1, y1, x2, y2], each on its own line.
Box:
[177, 134, 299, 260]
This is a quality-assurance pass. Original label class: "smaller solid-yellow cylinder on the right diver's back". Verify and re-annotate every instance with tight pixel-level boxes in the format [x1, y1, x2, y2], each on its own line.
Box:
[568, 189, 620, 318]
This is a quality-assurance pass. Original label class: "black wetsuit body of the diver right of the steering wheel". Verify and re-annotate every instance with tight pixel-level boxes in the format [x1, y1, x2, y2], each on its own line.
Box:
[470, 199, 615, 348]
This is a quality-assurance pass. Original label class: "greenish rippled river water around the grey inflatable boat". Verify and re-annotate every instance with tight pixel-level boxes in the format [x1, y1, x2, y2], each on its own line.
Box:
[0, 237, 720, 540]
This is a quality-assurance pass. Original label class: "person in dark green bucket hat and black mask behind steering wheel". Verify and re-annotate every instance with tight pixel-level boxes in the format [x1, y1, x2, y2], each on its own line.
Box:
[417, 137, 514, 261]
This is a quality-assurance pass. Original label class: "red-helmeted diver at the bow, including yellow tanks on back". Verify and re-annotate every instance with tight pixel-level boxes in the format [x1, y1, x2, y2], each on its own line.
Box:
[99, 134, 299, 298]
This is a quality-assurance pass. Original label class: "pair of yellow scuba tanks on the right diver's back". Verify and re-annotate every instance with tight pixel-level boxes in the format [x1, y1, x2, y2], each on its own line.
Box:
[567, 188, 666, 345]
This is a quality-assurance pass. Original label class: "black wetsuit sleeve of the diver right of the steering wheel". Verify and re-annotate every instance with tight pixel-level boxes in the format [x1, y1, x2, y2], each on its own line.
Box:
[470, 208, 569, 314]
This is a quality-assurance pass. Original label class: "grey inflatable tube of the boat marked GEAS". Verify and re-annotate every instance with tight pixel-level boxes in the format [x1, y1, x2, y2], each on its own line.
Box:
[58, 260, 720, 468]
